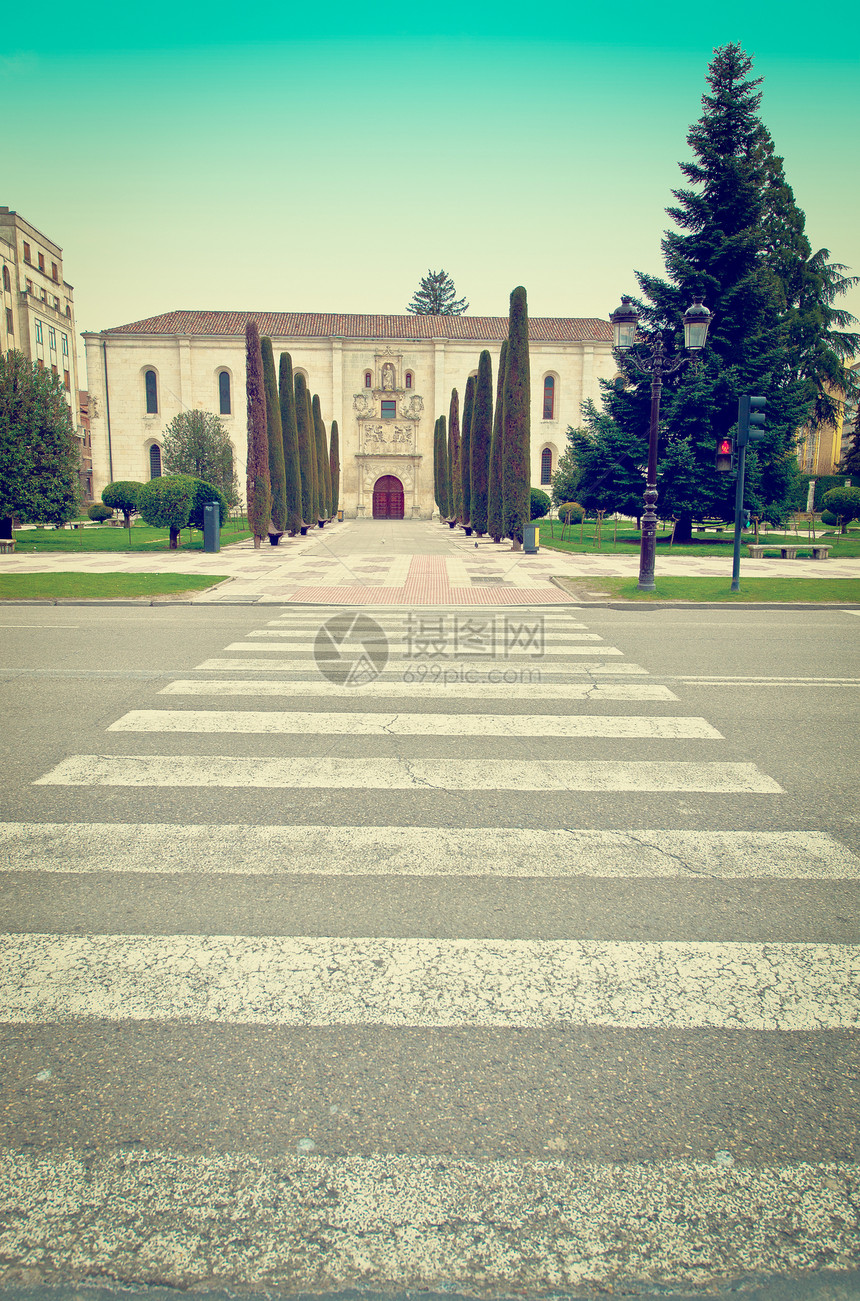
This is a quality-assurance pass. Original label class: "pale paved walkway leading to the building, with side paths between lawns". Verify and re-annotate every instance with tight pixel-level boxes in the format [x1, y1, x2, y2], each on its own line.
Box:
[0, 519, 860, 606]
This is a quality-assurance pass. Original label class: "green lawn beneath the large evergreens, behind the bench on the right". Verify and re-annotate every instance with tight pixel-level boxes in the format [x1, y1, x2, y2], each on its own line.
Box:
[540, 519, 860, 559]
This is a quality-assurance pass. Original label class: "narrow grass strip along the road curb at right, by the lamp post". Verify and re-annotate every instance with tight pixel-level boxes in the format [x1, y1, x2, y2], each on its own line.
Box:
[565, 574, 860, 604]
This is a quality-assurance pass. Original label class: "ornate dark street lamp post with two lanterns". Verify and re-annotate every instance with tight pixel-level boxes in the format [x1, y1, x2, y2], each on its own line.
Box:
[609, 295, 710, 592]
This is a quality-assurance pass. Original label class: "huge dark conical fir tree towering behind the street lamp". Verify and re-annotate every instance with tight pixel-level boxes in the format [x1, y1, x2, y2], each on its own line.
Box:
[604, 44, 809, 540]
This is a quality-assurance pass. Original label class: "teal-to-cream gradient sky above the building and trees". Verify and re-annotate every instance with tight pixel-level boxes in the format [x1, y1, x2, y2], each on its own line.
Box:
[0, 0, 860, 385]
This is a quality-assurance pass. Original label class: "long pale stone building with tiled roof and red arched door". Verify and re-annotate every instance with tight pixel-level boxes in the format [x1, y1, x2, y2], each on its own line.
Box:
[83, 311, 615, 519]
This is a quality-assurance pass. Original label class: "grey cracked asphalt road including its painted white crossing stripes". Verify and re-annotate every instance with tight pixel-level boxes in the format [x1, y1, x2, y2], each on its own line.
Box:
[0, 606, 860, 1296]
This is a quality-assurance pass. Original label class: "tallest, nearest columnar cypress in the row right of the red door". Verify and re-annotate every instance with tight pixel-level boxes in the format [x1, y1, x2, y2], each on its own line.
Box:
[502, 285, 531, 552]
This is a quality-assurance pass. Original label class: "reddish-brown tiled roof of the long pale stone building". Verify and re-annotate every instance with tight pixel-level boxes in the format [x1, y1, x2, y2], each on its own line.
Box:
[104, 311, 611, 343]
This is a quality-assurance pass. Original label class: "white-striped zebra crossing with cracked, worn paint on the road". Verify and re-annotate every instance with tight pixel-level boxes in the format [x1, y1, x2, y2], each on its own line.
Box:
[0, 609, 860, 1294]
